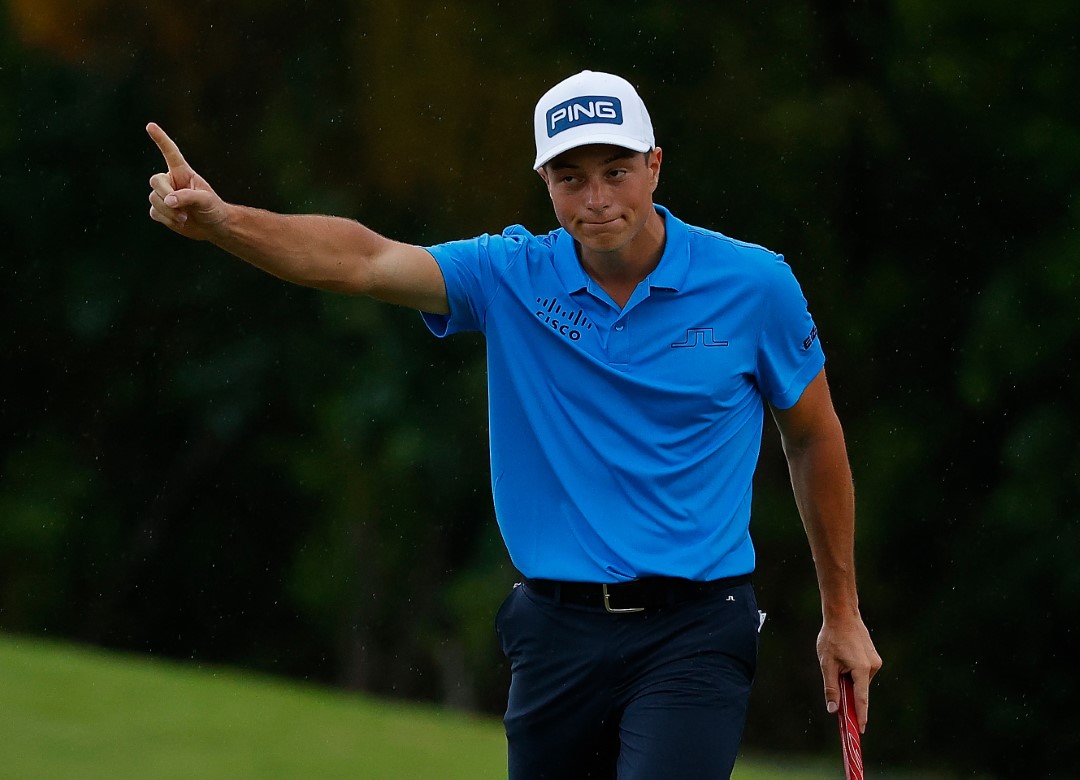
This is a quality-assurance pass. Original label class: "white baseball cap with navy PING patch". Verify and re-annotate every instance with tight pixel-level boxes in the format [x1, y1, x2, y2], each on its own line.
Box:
[532, 70, 656, 169]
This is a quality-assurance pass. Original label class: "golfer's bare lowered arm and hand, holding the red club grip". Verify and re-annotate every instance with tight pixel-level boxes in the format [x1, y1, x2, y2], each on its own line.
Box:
[773, 369, 881, 729]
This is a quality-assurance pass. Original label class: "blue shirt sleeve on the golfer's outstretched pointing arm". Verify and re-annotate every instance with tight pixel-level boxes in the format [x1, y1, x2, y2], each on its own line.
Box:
[422, 229, 523, 338]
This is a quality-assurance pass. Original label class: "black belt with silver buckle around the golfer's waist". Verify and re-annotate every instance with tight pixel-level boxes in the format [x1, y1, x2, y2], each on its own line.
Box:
[525, 574, 750, 614]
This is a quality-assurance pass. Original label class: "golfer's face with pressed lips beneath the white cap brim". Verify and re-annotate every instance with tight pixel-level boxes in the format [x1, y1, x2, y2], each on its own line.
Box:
[539, 144, 661, 258]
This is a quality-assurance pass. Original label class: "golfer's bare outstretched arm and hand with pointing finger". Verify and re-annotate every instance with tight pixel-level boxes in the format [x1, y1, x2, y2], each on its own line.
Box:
[146, 122, 449, 314]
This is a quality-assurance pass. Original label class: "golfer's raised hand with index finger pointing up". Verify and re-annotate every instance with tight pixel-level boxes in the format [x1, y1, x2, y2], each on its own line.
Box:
[146, 122, 228, 241]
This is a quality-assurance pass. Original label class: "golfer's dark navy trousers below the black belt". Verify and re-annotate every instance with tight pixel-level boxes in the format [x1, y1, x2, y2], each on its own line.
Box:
[496, 583, 760, 780]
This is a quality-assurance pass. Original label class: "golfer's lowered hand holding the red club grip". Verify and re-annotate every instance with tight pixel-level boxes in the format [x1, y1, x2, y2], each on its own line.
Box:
[818, 615, 881, 732]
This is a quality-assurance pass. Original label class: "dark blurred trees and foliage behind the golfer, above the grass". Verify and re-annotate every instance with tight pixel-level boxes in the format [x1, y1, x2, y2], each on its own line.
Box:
[0, 0, 1080, 778]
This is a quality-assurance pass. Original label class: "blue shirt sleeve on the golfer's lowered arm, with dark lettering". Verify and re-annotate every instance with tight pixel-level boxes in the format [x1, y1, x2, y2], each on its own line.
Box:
[757, 255, 825, 409]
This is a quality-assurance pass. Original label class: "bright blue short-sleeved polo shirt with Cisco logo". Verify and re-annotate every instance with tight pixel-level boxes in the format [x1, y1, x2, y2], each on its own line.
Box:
[423, 206, 825, 582]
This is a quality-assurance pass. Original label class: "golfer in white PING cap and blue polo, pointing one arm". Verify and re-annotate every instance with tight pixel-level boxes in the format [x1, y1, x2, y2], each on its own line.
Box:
[147, 70, 881, 780]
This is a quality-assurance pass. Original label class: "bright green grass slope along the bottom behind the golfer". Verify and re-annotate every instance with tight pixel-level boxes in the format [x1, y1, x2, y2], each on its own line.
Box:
[0, 635, 842, 780]
